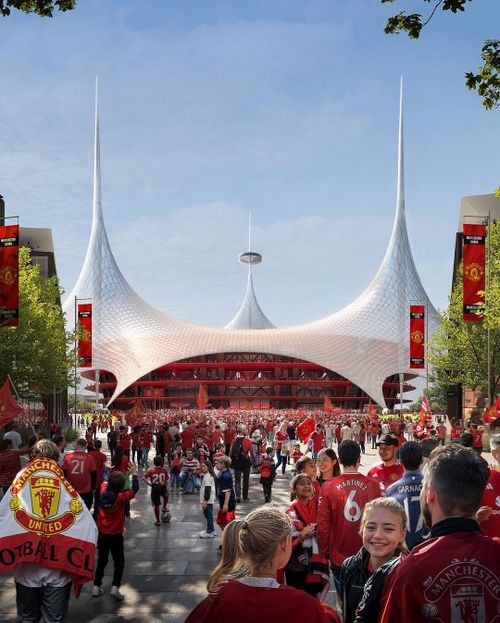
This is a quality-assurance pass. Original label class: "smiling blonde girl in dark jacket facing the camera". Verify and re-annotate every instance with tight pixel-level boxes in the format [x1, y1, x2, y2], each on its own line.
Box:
[337, 498, 406, 623]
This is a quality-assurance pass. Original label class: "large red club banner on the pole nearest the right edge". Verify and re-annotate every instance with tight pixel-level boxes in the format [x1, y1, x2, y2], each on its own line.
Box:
[463, 223, 486, 322]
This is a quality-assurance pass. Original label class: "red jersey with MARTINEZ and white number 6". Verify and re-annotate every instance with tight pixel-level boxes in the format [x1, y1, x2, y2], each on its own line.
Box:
[317, 473, 382, 567]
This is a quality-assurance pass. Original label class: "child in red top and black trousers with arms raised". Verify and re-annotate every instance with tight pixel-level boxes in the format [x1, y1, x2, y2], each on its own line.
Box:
[92, 462, 139, 601]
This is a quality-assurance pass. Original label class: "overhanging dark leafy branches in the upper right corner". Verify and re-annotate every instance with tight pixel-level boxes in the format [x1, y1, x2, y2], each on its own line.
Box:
[380, 0, 500, 110]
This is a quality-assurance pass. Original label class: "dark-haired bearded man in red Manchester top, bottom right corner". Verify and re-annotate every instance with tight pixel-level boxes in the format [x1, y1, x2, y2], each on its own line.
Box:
[379, 444, 500, 623]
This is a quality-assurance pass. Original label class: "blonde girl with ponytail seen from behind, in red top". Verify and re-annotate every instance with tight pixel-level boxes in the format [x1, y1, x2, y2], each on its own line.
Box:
[186, 506, 339, 623]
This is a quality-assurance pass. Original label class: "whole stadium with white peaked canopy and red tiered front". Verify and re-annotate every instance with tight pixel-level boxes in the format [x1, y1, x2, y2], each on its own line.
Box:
[64, 84, 437, 409]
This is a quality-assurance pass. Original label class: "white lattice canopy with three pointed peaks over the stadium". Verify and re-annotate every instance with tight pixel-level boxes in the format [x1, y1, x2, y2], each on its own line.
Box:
[64, 84, 437, 414]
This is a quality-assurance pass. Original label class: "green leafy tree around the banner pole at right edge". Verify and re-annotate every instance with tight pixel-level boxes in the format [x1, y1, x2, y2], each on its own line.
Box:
[429, 223, 500, 404]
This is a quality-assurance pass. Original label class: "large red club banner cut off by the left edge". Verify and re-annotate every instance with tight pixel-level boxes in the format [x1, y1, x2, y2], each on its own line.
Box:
[0, 225, 19, 327]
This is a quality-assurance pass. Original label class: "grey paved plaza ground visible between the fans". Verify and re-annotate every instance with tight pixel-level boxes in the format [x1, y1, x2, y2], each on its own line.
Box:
[0, 437, 490, 623]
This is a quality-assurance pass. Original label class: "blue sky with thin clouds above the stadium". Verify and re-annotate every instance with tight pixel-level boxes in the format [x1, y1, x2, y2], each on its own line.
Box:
[0, 0, 500, 326]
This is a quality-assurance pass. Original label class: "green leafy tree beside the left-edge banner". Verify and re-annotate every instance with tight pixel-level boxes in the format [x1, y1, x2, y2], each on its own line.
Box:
[0, 247, 75, 398]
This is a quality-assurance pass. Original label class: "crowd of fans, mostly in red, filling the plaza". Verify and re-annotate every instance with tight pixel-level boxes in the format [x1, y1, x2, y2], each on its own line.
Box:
[0, 410, 500, 623]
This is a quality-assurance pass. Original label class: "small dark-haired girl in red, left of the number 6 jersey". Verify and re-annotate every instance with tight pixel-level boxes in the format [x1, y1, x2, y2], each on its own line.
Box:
[285, 474, 330, 599]
